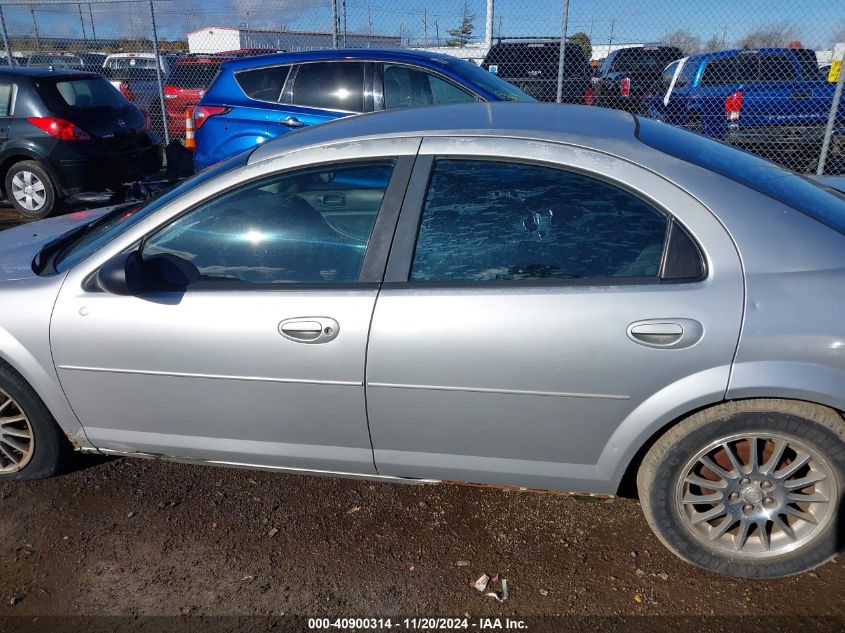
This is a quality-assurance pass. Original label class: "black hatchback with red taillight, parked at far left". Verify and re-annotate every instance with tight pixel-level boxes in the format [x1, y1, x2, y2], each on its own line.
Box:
[0, 67, 161, 218]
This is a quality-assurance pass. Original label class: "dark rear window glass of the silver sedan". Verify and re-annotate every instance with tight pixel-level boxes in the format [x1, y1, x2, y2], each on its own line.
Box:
[637, 117, 845, 235]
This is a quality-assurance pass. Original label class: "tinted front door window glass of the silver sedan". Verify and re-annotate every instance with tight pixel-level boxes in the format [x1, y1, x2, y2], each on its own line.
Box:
[144, 161, 393, 283]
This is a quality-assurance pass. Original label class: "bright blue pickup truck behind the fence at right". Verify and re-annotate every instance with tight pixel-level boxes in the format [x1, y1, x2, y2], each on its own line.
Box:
[644, 48, 845, 171]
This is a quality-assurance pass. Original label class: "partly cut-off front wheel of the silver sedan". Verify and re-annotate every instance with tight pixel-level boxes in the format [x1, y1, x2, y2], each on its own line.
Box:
[0, 361, 72, 481]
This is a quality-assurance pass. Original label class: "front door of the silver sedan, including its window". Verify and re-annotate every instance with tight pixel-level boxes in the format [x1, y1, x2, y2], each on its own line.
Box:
[51, 139, 419, 474]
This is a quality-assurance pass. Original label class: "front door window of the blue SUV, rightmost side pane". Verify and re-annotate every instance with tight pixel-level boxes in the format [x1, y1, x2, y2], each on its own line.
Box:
[384, 64, 477, 110]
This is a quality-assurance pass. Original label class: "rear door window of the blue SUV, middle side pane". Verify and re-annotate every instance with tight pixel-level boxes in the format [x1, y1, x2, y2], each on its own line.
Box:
[293, 62, 364, 112]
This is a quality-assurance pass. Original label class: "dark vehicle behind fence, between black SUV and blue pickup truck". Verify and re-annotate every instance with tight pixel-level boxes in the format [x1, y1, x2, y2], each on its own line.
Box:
[593, 45, 684, 113]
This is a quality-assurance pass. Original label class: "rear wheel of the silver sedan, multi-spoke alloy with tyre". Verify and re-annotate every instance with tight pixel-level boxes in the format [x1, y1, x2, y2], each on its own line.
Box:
[637, 400, 845, 578]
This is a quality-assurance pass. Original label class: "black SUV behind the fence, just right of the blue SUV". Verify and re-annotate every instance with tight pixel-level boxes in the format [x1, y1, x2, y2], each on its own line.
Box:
[481, 38, 592, 103]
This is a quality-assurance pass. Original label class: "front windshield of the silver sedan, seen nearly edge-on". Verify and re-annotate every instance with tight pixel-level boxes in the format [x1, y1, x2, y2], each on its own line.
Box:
[54, 151, 251, 273]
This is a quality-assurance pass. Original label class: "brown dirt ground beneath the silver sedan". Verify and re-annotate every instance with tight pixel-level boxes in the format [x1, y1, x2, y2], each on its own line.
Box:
[0, 205, 845, 631]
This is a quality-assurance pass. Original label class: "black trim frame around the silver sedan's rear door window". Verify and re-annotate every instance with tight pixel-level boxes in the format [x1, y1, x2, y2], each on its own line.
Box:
[384, 154, 710, 289]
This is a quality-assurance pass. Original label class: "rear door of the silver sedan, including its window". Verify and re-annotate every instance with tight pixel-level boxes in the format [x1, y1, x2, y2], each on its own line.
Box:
[367, 138, 743, 492]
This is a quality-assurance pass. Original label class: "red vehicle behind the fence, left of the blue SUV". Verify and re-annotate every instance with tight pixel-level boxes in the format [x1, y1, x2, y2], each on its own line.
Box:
[164, 55, 231, 138]
